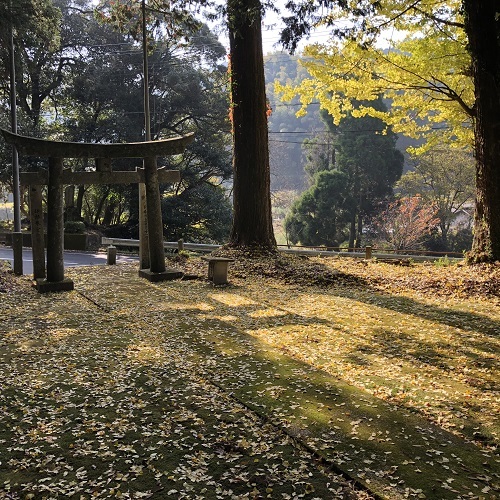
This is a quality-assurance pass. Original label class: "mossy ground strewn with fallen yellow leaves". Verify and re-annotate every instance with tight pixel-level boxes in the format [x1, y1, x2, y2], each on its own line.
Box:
[0, 251, 500, 499]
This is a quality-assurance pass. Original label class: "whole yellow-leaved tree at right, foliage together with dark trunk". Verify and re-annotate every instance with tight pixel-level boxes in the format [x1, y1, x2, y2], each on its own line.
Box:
[278, 0, 500, 262]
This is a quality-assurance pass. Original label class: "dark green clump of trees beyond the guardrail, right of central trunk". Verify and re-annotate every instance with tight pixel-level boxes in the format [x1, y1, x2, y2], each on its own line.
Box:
[286, 100, 403, 249]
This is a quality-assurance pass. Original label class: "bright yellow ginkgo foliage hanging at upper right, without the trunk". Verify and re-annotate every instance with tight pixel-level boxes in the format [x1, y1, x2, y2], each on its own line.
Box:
[276, 1, 474, 152]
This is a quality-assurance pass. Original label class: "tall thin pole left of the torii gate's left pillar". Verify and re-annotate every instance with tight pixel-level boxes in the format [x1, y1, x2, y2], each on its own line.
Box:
[9, 0, 23, 275]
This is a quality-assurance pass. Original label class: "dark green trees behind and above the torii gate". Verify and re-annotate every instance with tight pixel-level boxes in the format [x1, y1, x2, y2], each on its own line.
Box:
[0, 0, 231, 241]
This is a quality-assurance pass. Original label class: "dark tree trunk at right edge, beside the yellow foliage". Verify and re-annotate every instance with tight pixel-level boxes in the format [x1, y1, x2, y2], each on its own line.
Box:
[463, 0, 500, 262]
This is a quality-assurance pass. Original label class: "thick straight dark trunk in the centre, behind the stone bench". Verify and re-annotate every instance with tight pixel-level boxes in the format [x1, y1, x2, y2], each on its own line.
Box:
[228, 0, 276, 250]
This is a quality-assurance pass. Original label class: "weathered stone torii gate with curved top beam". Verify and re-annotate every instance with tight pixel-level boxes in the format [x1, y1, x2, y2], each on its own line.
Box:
[0, 129, 194, 292]
